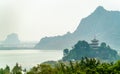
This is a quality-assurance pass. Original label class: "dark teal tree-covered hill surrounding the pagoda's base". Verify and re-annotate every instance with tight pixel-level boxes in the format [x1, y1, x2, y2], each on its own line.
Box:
[63, 41, 119, 61]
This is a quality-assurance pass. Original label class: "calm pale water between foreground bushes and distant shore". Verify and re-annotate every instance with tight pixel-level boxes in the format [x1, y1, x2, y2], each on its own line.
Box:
[0, 49, 63, 69]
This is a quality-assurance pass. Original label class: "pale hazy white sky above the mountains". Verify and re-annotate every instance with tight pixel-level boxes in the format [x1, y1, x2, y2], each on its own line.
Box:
[0, 0, 120, 41]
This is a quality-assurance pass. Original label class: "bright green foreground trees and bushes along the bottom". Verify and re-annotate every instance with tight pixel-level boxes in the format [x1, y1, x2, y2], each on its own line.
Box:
[0, 57, 120, 74]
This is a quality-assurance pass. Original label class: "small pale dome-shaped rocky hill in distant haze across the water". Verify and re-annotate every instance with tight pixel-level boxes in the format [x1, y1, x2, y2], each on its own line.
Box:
[3, 33, 20, 44]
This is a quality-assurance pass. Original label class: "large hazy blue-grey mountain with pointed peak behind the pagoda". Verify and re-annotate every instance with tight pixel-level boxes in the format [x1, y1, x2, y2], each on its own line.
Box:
[35, 6, 120, 49]
